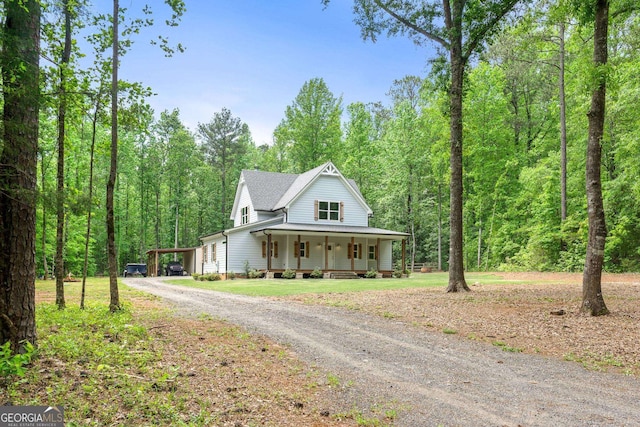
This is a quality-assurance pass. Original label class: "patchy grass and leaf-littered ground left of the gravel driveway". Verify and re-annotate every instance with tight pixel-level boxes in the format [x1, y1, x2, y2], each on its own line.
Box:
[0, 278, 386, 426]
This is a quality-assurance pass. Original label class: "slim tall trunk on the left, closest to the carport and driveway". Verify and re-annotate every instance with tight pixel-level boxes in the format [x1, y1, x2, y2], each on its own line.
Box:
[107, 0, 120, 312]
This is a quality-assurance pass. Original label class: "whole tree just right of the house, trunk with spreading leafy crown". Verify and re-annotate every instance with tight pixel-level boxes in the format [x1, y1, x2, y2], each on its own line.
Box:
[322, 0, 518, 292]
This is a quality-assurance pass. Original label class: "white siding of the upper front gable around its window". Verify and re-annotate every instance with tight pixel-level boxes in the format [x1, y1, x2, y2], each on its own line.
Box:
[287, 175, 369, 227]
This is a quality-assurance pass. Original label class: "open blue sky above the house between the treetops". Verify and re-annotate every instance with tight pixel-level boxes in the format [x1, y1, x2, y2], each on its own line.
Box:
[112, 0, 434, 145]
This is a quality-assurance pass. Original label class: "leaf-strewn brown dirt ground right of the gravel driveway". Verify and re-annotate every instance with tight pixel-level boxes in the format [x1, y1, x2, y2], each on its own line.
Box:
[286, 273, 640, 376]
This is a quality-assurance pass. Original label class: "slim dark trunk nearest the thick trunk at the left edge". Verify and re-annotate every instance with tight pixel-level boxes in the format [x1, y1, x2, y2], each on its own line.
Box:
[55, 0, 71, 310]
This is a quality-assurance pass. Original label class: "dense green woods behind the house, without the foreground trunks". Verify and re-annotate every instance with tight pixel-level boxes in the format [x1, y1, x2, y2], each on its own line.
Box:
[26, 0, 640, 276]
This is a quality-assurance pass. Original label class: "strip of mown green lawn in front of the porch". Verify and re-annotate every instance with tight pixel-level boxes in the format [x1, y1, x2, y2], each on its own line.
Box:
[168, 273, 518, 296]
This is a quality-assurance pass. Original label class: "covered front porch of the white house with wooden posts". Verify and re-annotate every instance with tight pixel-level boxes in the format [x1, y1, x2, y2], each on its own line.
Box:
[252, 223, 407, 277]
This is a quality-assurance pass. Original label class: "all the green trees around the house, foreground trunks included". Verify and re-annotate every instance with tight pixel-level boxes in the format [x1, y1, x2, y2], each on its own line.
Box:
[0, 0, 640, 349]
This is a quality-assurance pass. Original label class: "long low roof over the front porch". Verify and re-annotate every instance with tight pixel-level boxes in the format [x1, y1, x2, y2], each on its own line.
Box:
[251, 223, 409, 240]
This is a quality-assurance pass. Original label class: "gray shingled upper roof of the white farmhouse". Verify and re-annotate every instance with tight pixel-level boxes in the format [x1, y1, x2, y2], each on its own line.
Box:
[242, 162, 364, 211]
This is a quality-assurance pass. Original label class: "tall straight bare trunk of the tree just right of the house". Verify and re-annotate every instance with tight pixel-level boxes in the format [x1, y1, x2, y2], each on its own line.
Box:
[447, 10, 470, 292]
